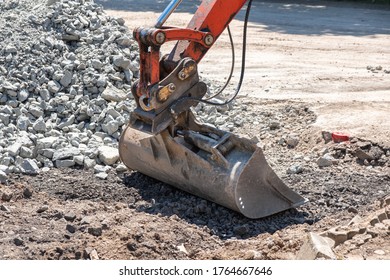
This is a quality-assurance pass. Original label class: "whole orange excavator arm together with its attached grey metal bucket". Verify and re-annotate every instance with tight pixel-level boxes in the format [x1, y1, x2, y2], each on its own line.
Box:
[119, 0, 306, 218]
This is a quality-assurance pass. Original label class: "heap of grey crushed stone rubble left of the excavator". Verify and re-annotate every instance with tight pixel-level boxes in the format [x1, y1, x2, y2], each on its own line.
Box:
[0, 0, 139, 182]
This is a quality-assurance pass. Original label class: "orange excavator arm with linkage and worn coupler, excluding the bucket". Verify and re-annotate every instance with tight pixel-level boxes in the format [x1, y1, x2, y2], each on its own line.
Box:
[129, 0, 251, 133]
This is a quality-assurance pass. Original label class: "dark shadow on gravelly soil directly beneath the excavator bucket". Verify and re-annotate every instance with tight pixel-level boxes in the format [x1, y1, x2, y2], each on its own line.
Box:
[123, 172, 317, 239]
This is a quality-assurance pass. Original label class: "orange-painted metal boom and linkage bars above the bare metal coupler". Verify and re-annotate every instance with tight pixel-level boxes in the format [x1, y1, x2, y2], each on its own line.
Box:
[134, 0, 247, 97]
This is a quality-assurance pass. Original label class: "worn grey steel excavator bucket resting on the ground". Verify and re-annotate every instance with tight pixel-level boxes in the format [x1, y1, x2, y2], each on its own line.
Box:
[119, 113, 306, 219]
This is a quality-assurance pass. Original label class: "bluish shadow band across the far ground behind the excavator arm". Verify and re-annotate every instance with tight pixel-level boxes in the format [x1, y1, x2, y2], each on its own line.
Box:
[95, 0, 390, 36]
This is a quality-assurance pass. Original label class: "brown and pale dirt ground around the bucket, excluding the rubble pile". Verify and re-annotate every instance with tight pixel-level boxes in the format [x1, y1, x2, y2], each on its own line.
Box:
[0, 0, 390, 260]
